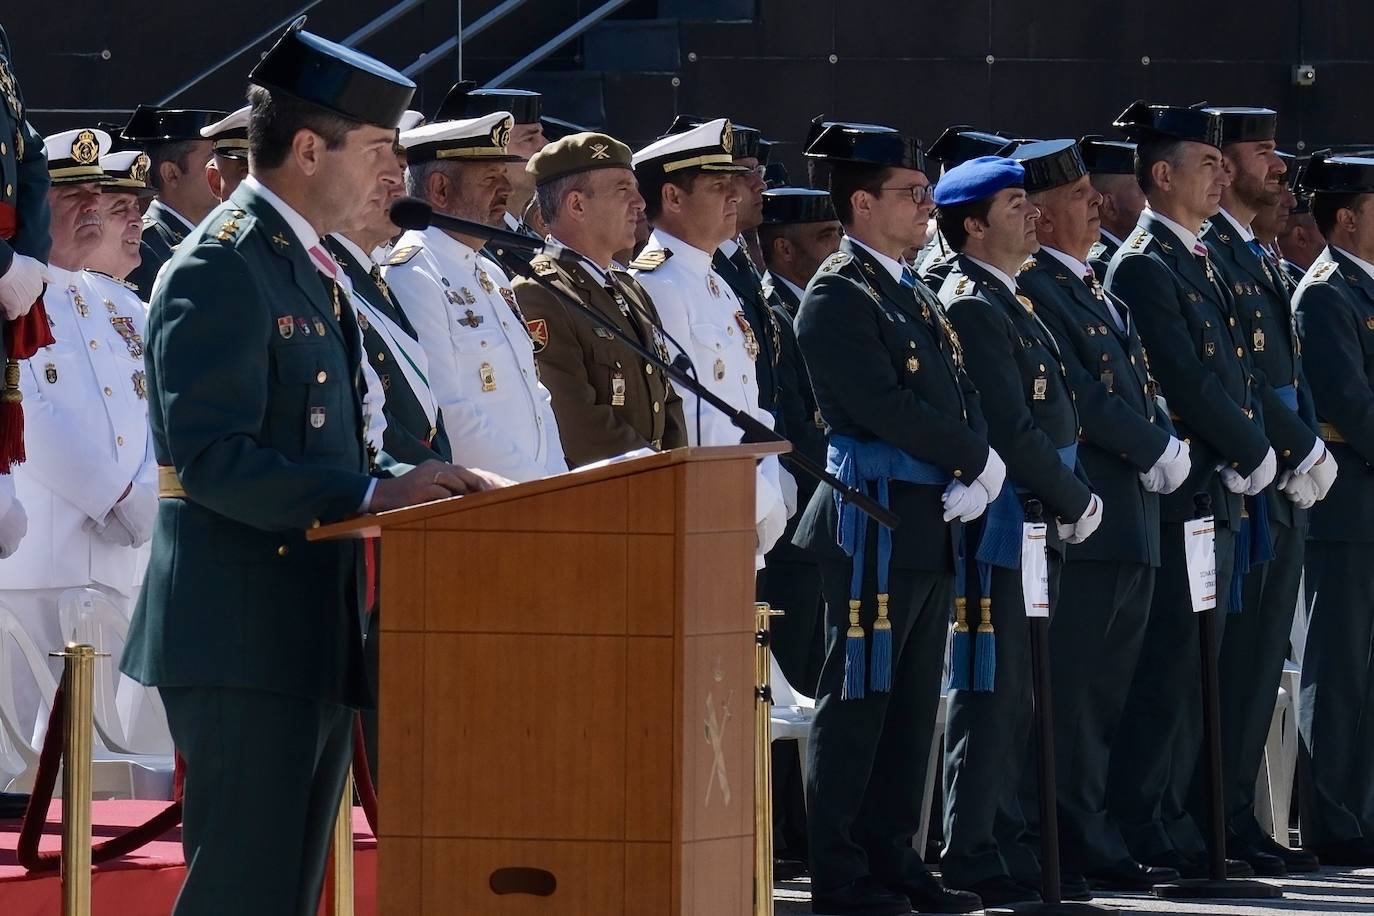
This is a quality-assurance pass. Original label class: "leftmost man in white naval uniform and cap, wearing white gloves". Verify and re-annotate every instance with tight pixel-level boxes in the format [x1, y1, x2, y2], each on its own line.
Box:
[0, 129, 157, 747]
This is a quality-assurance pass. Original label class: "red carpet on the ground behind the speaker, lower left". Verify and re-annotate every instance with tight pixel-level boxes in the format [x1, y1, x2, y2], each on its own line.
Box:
[0, 802, 376, 916]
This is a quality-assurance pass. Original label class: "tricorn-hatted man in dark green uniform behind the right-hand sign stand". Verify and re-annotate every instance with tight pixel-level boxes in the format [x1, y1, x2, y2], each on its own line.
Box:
[1105, 102, 1276, 876]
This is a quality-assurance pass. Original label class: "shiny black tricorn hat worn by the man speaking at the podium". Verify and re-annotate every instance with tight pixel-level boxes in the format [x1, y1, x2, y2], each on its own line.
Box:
[248, 16, 415, 128]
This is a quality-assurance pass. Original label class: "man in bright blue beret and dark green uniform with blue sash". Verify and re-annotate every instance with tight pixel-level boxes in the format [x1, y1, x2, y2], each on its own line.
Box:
[936, 155, 1103, 906]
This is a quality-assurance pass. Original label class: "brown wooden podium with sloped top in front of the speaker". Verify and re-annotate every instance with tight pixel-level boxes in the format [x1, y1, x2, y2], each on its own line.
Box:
[312, 445, 786, 916]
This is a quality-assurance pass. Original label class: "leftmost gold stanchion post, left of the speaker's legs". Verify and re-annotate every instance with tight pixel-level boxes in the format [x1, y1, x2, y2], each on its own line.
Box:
[54, 643, 98, 916]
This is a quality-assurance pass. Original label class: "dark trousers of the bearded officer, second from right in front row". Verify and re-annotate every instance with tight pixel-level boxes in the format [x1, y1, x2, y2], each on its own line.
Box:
[1214, 523, 1307, 842]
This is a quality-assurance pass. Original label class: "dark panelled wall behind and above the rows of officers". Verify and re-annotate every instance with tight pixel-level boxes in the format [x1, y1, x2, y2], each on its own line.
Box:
[0, 0, 1374, 177]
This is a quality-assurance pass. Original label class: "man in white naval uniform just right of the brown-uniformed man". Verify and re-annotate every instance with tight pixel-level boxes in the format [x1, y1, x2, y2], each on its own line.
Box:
[629, 118, 797, 569]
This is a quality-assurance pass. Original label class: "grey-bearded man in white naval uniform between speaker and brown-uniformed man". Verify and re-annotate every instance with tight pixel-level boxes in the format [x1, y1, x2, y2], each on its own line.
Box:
[385, 111, 567, 481]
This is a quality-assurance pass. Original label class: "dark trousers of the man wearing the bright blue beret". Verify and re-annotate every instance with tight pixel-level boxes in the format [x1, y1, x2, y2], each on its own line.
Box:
[940, 551, 1061, 887]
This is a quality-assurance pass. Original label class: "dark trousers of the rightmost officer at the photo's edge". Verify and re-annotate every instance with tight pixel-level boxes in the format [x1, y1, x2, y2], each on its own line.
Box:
[1298, 541, 1374, 846]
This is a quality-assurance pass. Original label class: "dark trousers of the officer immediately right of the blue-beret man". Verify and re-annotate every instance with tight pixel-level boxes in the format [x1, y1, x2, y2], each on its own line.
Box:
[1044, 558, 1156, 873]
